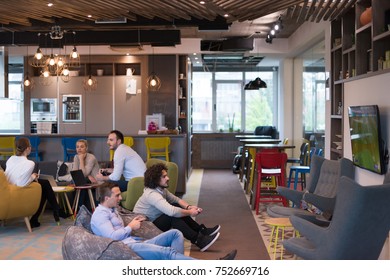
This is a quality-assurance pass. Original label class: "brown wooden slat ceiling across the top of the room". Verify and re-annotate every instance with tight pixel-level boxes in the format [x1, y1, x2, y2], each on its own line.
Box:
[0, 0, 358, 36]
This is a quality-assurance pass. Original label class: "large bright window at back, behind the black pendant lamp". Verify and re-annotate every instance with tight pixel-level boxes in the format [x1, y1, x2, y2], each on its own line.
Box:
[192, 68, 278, 132]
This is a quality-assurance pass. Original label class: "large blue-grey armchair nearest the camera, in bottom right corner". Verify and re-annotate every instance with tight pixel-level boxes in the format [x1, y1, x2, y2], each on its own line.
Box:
[283, 177, 390, 260]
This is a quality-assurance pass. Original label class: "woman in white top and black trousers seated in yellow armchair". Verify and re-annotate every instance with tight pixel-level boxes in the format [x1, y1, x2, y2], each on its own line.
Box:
[5, 137, 69, 228]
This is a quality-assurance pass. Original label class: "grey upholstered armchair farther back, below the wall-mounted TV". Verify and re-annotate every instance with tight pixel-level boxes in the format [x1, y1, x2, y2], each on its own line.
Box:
[267, 155, 355, 220]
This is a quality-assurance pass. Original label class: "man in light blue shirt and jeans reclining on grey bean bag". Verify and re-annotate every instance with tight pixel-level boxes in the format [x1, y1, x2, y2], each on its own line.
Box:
[91, 182, 236, 260]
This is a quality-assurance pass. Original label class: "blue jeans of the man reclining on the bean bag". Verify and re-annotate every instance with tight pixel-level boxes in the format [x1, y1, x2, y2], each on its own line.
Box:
[127, 229, 194, 260]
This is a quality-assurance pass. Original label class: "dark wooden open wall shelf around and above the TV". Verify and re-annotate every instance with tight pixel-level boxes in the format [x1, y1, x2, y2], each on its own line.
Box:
[330, 0, 390, 159]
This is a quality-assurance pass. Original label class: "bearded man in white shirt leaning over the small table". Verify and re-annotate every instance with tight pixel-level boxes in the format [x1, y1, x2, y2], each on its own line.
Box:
[96, 130, 146, 192]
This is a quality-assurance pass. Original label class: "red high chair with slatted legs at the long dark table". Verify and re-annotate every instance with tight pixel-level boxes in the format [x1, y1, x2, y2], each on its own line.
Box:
[255, 150, 288, 215]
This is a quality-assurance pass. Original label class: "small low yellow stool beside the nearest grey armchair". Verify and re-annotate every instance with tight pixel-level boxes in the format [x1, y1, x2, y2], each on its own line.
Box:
[264, 218, 300, 260]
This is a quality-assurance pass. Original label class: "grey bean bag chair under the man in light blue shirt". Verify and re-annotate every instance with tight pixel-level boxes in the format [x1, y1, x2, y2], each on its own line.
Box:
[62, 205, 161, 260]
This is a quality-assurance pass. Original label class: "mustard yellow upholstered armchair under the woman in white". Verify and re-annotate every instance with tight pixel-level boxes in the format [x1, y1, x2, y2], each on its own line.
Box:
[0, 171, 42, 232]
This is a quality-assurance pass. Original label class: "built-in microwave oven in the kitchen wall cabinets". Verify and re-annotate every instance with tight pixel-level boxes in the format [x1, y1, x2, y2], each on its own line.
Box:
[30, 98, 57, 121]
